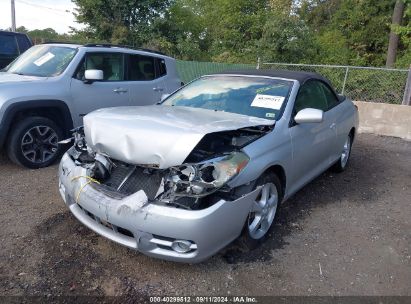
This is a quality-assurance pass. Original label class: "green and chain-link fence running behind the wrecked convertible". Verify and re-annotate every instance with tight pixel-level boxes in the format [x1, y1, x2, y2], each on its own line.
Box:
[177, 60, 409, 104]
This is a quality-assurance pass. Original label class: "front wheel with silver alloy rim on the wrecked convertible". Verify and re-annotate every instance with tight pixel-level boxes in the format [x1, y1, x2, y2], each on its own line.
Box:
[239, 172, 283, 251]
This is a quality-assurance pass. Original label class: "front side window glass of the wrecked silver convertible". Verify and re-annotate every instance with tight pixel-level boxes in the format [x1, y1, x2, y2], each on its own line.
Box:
[294, 80, 328, 113]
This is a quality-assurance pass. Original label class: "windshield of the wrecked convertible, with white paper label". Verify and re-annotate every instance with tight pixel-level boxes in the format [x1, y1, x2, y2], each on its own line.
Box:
[163, 76, 293, 119]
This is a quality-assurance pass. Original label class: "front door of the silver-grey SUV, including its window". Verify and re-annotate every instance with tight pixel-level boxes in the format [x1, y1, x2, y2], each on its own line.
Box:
[70, 52, 130, 117]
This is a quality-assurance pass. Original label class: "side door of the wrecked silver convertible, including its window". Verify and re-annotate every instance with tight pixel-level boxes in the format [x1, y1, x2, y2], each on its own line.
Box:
[290, 80, 336, 189]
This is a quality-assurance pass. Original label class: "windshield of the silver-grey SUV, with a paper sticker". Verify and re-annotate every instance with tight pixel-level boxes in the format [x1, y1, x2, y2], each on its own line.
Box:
[5, 45, 76, 77]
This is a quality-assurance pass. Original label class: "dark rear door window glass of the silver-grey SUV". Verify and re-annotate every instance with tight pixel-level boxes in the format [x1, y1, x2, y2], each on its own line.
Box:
[128, 55, 156, 81]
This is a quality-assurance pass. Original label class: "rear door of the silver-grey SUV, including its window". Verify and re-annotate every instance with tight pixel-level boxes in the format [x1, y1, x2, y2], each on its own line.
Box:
[127, 54, 167, 106]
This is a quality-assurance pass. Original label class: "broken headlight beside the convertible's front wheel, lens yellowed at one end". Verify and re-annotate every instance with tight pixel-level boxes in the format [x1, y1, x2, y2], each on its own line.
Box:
[168, 152, 250, 197]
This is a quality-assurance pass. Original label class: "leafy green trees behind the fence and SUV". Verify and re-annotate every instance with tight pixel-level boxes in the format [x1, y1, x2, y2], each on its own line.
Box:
[14, 0, 411, 67]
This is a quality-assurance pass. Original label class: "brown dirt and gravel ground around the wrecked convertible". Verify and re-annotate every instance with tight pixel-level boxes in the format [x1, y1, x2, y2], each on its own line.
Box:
[0, 135, 411, 299]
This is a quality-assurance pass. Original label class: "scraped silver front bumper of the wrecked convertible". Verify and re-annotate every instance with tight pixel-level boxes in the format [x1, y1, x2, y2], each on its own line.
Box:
[59, 154, 260, 263]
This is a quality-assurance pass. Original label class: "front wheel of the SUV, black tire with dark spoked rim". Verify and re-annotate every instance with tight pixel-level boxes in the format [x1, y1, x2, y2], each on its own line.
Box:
[7, 116, 63, 169]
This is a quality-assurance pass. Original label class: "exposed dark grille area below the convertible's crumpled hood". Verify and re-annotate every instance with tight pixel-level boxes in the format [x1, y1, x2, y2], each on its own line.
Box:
[103, 162, 162, 200]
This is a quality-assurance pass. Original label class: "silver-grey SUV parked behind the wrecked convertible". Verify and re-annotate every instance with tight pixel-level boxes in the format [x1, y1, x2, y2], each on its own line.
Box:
[0, 43, 182, 168]
